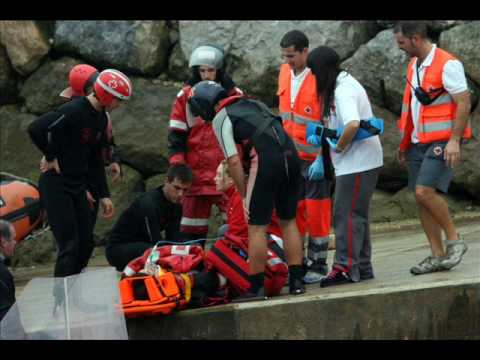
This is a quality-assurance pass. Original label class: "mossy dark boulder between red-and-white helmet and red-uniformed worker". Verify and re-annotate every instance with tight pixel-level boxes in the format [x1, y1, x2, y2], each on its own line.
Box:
[112, 78, 180, 177]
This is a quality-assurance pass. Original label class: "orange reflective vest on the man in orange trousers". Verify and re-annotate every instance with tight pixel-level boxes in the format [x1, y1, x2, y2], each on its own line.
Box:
[277, 64, 323, 161]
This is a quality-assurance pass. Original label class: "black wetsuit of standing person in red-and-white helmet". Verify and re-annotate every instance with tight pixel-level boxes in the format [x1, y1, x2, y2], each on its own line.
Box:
[28, 97, 110, 277]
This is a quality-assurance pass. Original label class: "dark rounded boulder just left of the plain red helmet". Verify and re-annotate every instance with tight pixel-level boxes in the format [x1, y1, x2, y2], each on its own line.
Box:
[20, 57, 81, 114]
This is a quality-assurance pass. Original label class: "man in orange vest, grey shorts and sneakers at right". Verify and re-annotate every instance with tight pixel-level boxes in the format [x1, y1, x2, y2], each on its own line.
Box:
[394, 21, 472, 275]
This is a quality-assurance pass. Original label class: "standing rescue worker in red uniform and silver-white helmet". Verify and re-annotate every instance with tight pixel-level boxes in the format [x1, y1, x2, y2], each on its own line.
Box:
[168, 45, 242, 246]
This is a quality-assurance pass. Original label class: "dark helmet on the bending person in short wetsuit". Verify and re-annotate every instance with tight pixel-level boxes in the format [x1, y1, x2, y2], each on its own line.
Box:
[188, 80, 228, 121]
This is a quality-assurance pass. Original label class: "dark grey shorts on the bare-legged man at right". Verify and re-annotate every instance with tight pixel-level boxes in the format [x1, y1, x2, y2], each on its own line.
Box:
[407, 141, 453, 193]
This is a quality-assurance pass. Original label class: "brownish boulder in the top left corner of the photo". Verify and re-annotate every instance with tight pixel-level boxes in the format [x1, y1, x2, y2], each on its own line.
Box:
[0, 21, 51, 75]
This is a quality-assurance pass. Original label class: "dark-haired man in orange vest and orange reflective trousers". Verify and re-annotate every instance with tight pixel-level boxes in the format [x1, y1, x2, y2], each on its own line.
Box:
[277, 30, 333, 283]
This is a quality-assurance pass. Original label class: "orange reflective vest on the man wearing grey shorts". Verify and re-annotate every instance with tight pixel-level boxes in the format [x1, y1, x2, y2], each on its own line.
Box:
[397, 48, 472, 151]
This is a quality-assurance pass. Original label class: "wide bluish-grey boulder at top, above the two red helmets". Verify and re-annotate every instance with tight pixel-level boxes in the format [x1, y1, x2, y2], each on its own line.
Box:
[54, 21, 170, 75]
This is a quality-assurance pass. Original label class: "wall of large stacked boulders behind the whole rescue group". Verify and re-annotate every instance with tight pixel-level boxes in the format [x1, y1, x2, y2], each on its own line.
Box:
[0, 21, 480, 248]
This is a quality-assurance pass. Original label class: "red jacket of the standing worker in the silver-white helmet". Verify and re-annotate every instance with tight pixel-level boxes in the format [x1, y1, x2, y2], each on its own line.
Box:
[168, 86, 242, 195]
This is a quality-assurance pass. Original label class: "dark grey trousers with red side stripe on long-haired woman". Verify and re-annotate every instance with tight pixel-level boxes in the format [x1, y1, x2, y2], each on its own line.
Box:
[333, 168, 381, 282]
